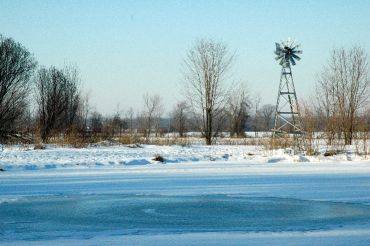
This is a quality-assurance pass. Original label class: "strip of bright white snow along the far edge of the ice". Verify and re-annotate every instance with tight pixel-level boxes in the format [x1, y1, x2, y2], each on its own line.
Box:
[0, 145, 366, 171]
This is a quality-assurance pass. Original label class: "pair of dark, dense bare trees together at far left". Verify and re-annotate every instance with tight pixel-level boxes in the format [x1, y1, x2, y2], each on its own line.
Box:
[0, 36, 87, 142]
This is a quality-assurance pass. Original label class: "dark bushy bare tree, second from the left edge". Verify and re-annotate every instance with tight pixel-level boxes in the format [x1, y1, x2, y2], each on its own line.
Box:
[36, 67, 80, 142]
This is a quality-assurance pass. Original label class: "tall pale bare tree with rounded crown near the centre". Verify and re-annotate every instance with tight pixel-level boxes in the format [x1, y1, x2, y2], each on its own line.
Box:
[184, 40, 234, 145]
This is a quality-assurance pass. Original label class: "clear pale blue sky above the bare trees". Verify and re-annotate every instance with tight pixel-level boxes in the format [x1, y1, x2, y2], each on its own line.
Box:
[0, 0, 370, 114]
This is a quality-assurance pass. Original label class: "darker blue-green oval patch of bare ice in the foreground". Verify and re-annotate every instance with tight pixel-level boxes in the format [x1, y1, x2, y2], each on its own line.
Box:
[0, 194, 370, 240]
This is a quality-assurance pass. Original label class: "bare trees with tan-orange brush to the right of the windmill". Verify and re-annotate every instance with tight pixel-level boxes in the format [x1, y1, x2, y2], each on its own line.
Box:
[304, 46, 370, 145]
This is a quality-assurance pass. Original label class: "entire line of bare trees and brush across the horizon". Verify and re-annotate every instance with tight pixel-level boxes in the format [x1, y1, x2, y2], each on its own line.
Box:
[0, 36, 370, 144]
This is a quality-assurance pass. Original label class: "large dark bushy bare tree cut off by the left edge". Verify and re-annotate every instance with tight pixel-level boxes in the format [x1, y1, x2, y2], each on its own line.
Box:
[0, 35, 36, 141]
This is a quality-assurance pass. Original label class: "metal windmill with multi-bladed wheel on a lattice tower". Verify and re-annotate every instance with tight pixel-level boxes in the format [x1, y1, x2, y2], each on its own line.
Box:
[272, 38, 304, 148]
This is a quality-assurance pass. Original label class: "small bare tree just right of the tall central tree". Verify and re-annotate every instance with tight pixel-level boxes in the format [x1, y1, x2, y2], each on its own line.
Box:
[227, 85, 250, 137]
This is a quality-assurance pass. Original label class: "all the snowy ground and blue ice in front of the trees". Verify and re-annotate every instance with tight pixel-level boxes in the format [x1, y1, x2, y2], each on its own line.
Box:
[0, 146, 370, 245]
